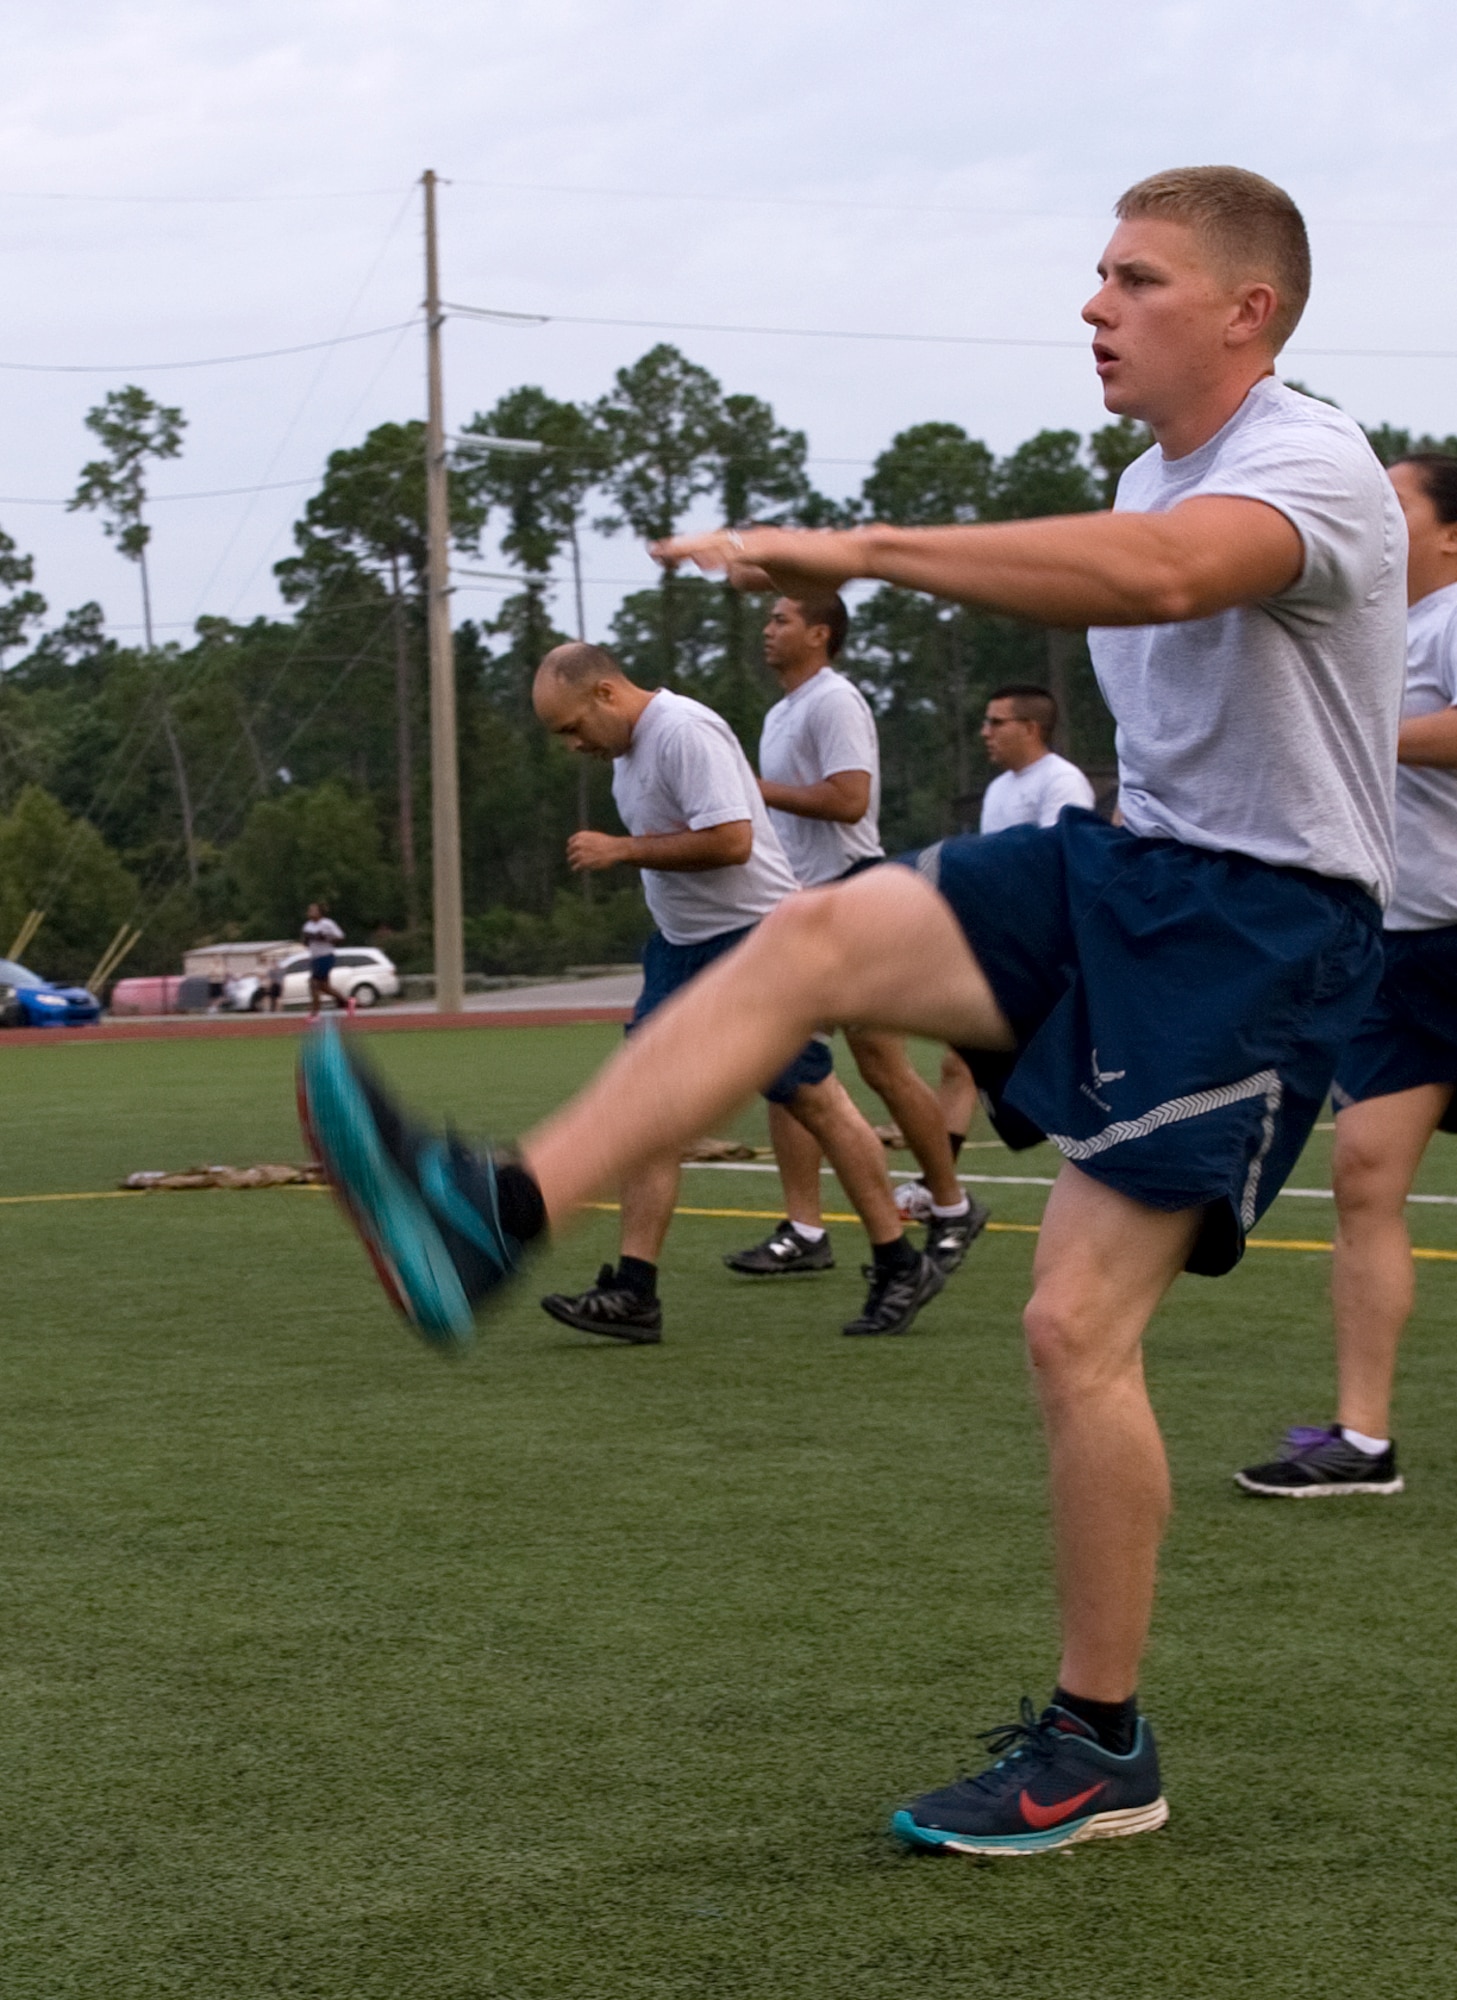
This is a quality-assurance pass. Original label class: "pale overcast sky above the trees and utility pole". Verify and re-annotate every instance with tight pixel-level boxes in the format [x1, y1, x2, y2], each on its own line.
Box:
[0, 0, 1457, 638]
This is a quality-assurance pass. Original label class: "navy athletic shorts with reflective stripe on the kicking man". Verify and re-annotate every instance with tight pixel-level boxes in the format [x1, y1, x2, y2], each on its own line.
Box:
[903, 808, 1381, 1276]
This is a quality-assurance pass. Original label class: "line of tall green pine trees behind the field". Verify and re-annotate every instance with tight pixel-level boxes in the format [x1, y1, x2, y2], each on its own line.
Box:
[0, 344, 1457, 978]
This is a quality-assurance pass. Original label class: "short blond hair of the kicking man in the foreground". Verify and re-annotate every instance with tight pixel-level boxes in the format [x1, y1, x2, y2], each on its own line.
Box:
[1113, 166, 1311, 354]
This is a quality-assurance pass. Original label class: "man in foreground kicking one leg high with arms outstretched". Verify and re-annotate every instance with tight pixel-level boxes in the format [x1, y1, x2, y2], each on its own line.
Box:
[306, 166, 1407, 1854]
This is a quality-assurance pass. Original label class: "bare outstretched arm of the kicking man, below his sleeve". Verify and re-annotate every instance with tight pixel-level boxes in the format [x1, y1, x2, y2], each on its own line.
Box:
[652, 494, 1305, 626]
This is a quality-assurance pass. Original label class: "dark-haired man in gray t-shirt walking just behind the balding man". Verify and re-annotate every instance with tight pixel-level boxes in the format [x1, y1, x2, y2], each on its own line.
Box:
[724, 590, 987, 1278]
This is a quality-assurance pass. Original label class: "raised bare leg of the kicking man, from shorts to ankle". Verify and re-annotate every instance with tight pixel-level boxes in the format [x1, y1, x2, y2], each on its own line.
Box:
[522, 866, 1013, 1222]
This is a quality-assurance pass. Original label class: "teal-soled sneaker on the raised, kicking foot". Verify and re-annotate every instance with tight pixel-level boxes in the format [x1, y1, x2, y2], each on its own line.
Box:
[298, 1022, 544, 1348]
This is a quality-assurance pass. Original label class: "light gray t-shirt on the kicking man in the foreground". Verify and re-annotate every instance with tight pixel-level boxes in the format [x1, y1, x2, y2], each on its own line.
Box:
[1089, 378, 1407, 904]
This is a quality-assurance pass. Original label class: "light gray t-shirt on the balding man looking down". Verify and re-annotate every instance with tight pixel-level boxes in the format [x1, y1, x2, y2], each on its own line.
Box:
[612, 688, 797, 944]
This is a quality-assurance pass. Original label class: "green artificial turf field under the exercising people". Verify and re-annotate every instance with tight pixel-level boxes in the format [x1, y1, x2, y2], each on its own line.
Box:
[0, 1028, 1457, 2000]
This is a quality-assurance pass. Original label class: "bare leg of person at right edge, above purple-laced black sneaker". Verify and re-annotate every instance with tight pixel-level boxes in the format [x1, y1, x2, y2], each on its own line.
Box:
[1331, 1084, 1451, 1438]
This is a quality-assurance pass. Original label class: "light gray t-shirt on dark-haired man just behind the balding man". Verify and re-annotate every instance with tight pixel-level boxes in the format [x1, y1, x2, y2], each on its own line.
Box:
[759, 666, 885, 888]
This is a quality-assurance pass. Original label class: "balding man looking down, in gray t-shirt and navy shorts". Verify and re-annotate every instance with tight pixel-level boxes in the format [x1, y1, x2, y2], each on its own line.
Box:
[532, 644, 945, 1342]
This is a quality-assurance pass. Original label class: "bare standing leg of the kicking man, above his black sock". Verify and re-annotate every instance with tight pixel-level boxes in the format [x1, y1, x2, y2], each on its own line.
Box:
[1027, 1166, 1199, 1702]
